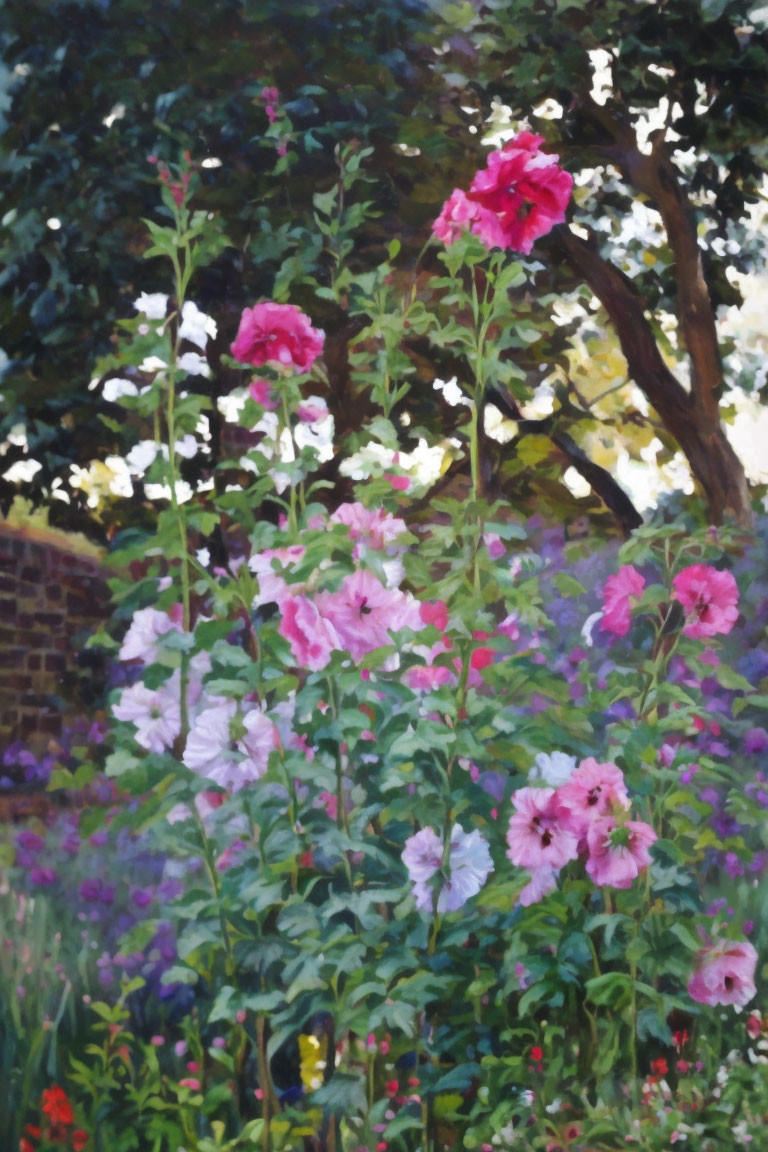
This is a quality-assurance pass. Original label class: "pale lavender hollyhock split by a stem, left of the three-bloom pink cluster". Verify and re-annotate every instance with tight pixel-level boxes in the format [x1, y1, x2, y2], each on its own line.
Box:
[403, 824, 493, 912]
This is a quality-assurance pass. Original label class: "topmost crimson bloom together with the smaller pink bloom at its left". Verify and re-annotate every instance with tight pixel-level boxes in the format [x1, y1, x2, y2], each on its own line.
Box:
[432, 132, 573, 255]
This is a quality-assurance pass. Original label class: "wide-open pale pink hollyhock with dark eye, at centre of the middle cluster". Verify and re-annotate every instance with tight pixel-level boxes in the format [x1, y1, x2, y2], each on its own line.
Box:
[317, 569, 423, 661]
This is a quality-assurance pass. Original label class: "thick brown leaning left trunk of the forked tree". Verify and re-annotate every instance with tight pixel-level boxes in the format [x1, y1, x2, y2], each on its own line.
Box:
[555, 226, 752, 524]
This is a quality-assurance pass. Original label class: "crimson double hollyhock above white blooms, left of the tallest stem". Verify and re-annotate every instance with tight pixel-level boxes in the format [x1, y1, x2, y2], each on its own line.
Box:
[230, 302, 325, 372]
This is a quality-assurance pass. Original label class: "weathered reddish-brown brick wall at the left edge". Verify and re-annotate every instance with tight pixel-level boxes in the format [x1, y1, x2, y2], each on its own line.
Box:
[0, 524, 109, 748]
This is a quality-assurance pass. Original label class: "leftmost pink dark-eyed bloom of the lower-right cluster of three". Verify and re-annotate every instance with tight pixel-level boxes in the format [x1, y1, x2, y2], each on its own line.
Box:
[507, 788, 578, 872]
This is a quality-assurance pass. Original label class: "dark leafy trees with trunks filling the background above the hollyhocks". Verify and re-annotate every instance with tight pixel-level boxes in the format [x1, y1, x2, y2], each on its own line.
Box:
[0, 0, 768, 535]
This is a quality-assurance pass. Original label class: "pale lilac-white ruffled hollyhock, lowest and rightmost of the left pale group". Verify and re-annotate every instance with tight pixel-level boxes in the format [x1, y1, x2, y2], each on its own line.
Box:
[182, 700, 277, 793]
